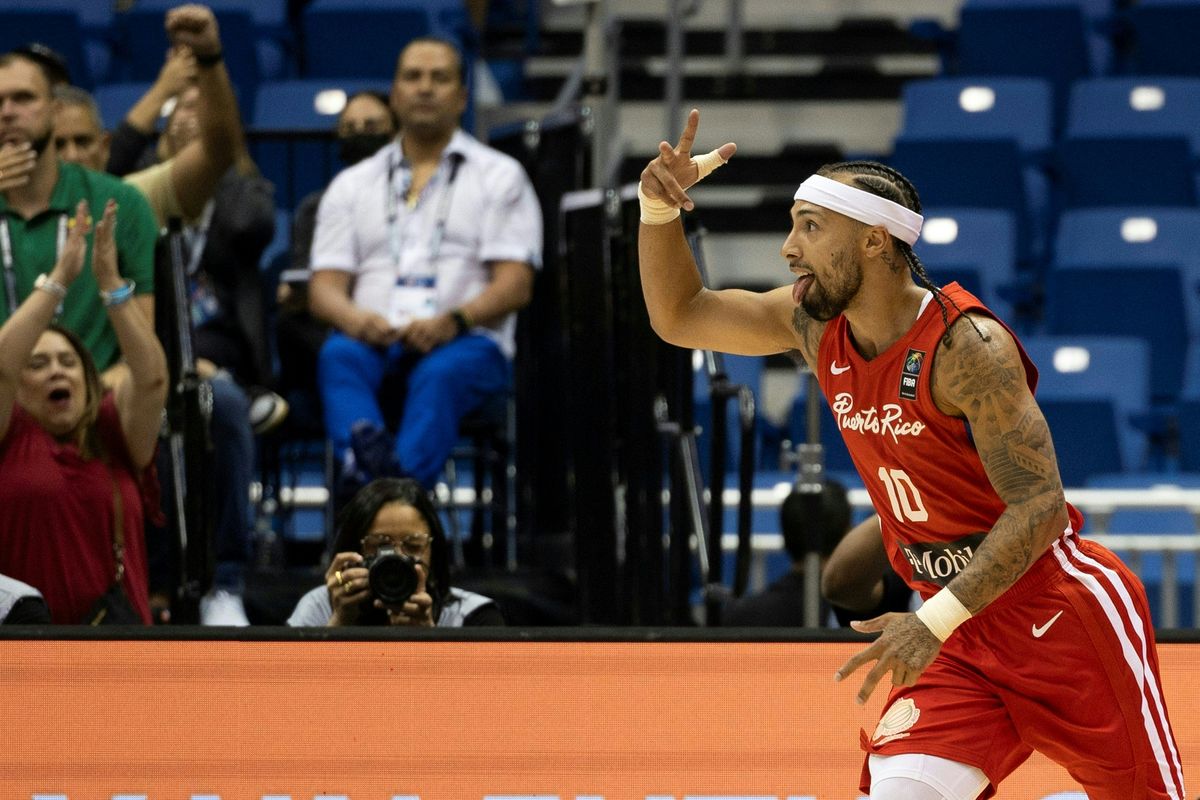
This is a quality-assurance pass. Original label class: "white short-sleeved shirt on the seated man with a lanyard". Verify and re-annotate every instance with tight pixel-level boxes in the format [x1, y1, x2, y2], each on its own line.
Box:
[312, 130, 542, 359]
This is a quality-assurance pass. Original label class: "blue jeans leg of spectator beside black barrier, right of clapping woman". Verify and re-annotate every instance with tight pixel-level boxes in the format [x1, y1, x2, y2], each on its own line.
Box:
[210, 374, 254, 594]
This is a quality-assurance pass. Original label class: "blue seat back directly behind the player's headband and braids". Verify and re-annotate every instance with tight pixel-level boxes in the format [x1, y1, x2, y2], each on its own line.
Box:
[916, 205, 1018, 323]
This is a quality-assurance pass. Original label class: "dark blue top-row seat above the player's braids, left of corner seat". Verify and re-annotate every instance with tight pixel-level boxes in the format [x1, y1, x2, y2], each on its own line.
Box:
[956, 0, 1112, 118]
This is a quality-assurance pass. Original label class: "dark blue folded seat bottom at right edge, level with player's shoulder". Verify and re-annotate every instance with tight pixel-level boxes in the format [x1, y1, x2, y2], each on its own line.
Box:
[1045, 259, 1187, 403]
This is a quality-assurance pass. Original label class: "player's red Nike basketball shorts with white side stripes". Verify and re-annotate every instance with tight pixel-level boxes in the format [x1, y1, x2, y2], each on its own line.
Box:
[860, 534, 1187, 800]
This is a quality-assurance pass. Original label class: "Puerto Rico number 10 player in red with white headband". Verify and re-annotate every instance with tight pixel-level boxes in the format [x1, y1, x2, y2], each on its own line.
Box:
[638, 110, 1186, 800]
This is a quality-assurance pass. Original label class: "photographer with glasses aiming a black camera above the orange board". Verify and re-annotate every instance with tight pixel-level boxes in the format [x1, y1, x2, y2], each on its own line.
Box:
[288, 479, 504, 627]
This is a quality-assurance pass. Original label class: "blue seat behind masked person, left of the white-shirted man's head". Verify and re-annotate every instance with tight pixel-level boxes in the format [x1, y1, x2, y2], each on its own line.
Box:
[248, 78, 388, 209]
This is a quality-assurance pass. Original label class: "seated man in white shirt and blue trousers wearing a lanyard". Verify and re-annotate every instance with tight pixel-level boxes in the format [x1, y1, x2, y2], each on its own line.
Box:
[310, 38, 542, 501]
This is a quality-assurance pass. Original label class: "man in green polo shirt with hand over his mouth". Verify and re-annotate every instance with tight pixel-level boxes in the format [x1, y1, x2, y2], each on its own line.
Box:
[0, 53, 158, 383]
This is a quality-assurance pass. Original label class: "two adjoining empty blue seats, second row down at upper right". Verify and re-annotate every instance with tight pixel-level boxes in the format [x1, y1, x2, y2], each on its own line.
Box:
[892, 77, 1200, 264]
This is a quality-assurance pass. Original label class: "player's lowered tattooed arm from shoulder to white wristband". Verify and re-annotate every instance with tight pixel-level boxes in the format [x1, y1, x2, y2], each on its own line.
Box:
[934, 314, 1068, 614]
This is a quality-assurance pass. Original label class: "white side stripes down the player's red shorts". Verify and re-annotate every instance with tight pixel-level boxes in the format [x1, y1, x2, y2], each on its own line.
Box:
[1052, 535, 1184, 800]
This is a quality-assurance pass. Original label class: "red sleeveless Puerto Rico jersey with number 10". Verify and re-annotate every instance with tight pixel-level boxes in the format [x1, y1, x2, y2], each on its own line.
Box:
[817, 283, 1082, 597]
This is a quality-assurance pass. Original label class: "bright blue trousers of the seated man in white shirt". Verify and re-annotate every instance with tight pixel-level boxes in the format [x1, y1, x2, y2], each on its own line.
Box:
[317, 333, 510, 488]
